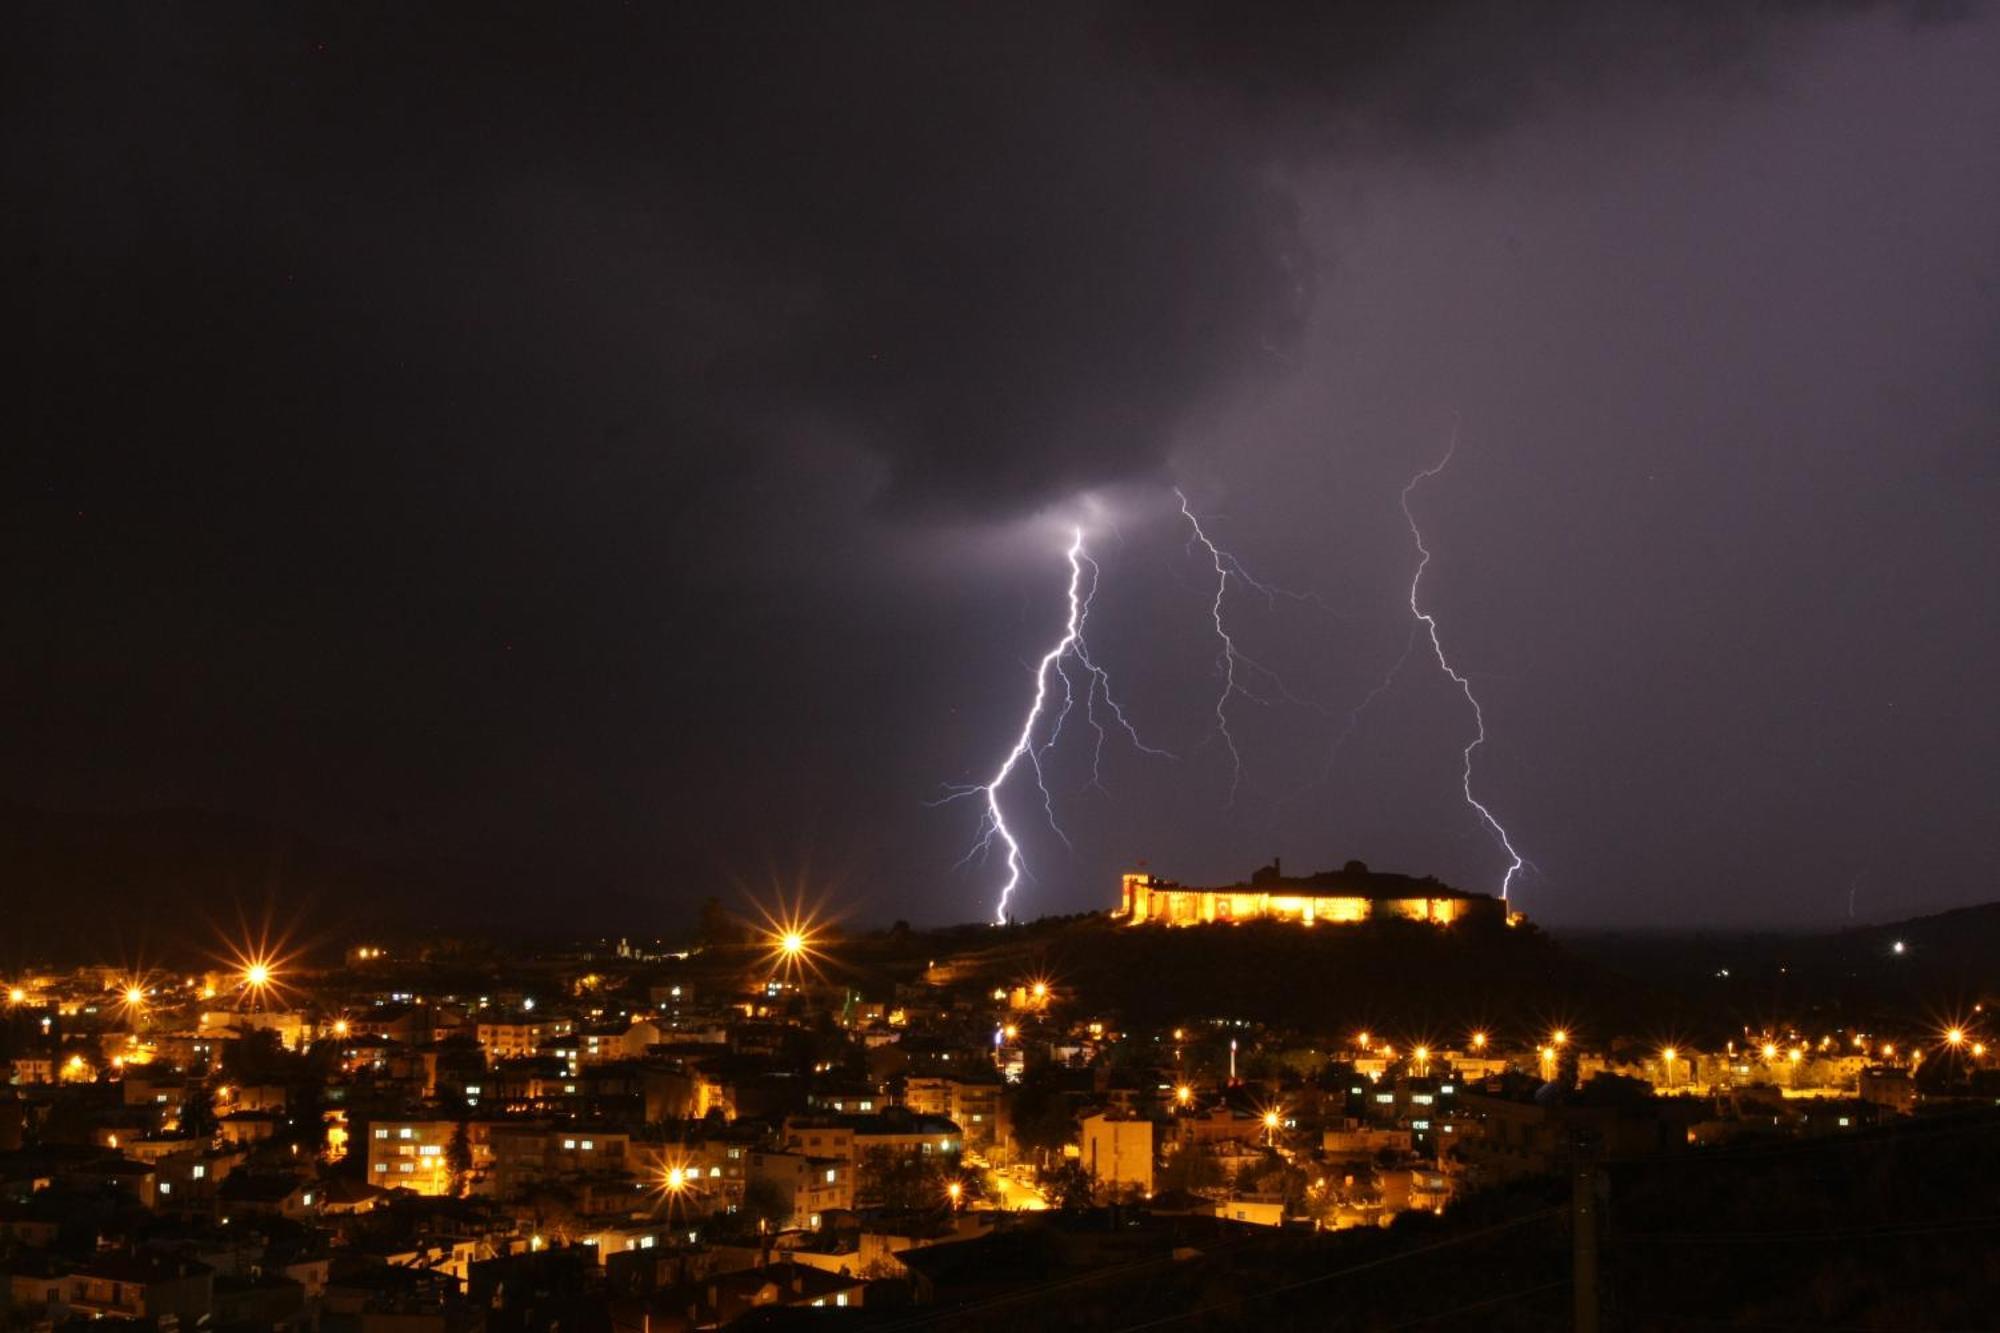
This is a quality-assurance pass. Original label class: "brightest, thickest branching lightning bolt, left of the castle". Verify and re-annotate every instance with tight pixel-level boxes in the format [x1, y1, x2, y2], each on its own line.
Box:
[932, 526, 1172, 925]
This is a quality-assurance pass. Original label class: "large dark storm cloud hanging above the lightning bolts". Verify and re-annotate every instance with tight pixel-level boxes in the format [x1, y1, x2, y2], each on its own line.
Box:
[10, 4, 1936, 512]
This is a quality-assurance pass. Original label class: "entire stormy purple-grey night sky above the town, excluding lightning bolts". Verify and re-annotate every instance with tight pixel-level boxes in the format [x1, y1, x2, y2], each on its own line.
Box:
[0, 0, 2000, 927]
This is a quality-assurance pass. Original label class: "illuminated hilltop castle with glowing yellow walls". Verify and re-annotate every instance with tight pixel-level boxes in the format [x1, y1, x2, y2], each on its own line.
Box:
[1116, 861, 1510, 925]
